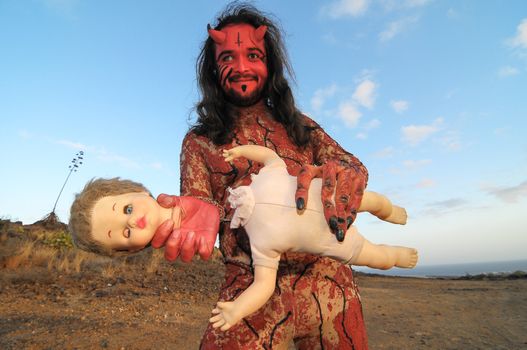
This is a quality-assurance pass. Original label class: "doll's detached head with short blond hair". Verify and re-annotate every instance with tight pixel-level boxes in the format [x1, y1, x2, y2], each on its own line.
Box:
[69, 178, 160, 256]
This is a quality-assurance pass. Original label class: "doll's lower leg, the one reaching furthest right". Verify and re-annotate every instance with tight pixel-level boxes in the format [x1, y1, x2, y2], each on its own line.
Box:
[353, 239, 418, 270]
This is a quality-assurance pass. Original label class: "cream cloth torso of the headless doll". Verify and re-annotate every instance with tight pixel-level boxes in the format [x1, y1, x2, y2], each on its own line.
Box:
[228, 159, 364, 269]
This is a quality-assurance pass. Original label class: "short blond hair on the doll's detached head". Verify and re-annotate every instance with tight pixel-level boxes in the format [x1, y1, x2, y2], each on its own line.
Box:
[68, 177, 150, 256]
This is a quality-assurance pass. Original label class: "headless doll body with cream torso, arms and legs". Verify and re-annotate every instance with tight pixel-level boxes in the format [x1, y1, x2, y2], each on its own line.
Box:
[210, 145, 417, 330]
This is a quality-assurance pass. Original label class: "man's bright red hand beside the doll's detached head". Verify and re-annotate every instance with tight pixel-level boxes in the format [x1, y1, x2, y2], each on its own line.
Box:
[152, 194, 220, 262]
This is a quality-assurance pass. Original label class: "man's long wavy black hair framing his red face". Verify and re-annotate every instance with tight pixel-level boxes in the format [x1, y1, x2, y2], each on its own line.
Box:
[192, 2, 311, 146]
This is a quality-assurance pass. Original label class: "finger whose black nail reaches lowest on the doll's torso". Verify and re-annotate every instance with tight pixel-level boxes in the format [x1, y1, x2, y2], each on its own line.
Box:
[335, 167, 355, 241]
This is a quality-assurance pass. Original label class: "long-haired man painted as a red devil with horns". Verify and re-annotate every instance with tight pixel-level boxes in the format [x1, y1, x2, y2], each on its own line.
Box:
[153, 4, 367, 349]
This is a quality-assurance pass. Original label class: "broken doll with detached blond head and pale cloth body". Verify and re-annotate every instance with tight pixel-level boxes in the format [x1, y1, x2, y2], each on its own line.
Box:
[69, 145, 417, 331]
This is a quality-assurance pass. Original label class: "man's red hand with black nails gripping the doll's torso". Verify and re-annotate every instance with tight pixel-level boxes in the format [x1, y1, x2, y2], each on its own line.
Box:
[295, 161, 366, 242]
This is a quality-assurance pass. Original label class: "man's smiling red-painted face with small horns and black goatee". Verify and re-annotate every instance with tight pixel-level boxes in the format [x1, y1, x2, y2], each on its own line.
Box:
[209, 24, 267, 106]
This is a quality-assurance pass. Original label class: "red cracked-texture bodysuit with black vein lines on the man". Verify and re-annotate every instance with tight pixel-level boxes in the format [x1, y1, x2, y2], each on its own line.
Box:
[181, 105, 367, 349]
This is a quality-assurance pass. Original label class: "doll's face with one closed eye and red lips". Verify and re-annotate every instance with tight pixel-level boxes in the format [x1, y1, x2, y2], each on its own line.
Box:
[91, 192, 160, 251]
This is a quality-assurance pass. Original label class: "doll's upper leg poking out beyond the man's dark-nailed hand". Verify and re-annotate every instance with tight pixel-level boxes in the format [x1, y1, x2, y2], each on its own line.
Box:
[358, 191, 408, 225]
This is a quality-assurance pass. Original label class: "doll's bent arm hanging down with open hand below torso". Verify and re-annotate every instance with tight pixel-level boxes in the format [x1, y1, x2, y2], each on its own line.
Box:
[209, 265, 276, 331]
